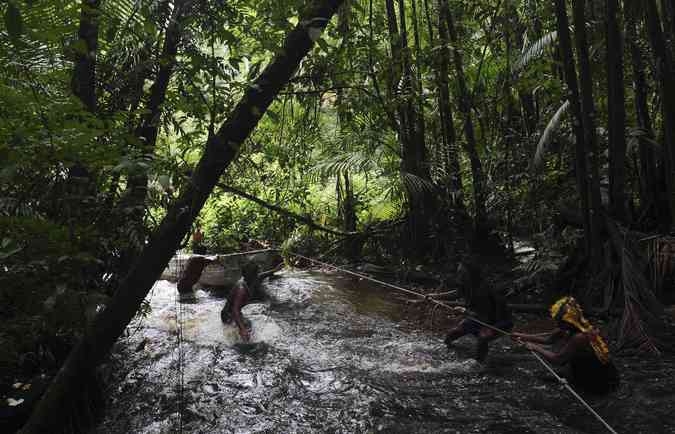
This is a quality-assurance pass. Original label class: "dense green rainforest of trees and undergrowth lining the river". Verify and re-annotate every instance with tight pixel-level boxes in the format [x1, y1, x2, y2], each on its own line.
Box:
[0, 0, 675, 432]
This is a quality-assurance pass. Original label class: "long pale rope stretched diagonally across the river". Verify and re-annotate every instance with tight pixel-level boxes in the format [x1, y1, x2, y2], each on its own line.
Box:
[288, 252, 617, 434]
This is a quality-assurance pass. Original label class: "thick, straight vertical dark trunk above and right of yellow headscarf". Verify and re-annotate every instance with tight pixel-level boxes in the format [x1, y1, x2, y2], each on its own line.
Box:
[605, 0, 627, 222]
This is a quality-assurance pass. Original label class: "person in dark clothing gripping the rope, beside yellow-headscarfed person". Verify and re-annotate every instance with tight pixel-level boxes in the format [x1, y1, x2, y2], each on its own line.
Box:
[445, 261, 513, 361]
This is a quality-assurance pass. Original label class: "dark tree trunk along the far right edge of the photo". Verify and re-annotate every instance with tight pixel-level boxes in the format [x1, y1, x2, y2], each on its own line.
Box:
[645, 0, 675, 231]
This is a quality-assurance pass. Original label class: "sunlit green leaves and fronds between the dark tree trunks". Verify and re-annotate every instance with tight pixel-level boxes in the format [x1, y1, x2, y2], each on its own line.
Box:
[0, 0, 664, 372]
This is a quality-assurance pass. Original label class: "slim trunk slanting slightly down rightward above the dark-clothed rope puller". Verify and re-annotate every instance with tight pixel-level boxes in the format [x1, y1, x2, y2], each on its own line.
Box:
[441, 0, 489, 238]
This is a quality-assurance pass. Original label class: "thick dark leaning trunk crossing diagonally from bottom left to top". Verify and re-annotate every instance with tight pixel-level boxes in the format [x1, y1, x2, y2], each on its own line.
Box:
[21, 0, 342, 433]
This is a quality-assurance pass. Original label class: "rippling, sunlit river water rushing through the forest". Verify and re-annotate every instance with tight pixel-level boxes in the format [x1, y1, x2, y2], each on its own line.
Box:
[98, 271, 675, 433]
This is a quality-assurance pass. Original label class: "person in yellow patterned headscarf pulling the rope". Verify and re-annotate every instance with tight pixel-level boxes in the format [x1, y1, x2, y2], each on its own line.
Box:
[511, 297, 619, 394]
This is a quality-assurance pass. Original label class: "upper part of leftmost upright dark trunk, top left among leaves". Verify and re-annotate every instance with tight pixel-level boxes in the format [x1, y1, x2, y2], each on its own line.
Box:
[71, 0, 101, 113]
